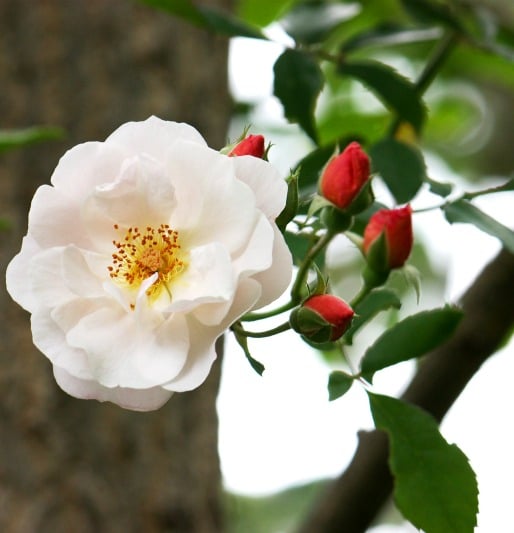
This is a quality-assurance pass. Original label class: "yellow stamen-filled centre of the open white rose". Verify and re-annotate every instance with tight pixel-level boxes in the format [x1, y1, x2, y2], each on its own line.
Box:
[107, 224, 186, 307]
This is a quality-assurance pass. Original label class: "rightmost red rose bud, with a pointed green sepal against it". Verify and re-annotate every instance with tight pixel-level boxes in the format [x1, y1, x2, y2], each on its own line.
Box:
[362, 205, 413, 272]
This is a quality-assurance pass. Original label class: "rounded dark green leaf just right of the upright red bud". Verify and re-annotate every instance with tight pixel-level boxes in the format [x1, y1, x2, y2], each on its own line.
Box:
[369, 139, 426, 204]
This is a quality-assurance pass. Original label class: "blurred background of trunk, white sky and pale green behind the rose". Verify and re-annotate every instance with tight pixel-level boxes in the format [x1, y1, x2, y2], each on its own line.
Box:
[0, 0, 514, 533]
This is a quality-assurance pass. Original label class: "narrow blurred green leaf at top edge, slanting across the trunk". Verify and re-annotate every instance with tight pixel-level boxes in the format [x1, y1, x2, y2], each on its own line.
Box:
[139, 0, 266, 39]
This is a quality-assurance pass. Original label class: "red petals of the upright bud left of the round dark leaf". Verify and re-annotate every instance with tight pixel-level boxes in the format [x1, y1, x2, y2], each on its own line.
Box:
[320, 142, 370, 209]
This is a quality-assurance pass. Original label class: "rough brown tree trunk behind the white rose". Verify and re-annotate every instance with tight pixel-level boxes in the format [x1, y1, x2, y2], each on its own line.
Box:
[0, 0, 229, 533]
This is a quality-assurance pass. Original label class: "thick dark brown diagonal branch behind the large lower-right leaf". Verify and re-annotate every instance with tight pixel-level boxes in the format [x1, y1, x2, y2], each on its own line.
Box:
[298, 251, 514, 533]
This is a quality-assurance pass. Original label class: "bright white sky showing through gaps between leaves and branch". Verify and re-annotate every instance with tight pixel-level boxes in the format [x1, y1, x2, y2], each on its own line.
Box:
[218, 34, 514, 533]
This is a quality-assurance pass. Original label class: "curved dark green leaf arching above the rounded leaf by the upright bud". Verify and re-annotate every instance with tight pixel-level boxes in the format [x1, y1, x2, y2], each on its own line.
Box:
[339, 61, 426, 132]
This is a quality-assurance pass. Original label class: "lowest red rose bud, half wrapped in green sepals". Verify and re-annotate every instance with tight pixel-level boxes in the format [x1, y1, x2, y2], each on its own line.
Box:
[290, 294, 354, 343]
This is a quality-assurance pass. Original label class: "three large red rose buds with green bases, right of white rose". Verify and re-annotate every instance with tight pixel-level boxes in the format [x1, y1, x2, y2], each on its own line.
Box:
[291, 142, 413, 343]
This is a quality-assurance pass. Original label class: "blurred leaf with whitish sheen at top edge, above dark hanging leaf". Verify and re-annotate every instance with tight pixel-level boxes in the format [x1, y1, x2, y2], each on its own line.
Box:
[281, 3, 360, 44]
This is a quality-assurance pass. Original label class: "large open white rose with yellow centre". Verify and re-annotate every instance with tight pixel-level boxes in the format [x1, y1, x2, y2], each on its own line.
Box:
[7, 117, 292, 411]
